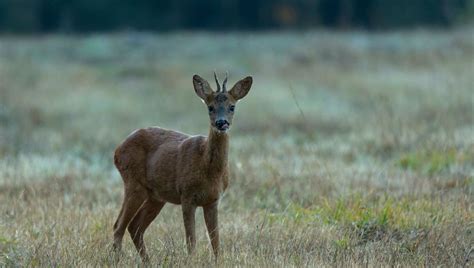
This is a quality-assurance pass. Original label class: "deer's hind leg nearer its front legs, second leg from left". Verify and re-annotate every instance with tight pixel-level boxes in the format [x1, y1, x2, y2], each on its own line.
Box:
[128, 198, 165, 263]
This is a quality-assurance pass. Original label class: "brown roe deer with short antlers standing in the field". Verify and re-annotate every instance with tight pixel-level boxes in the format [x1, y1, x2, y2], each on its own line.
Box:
[114, 73, 252, 262]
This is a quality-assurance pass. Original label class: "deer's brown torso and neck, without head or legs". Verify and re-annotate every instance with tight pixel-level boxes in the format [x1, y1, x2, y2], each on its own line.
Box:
[115, 127, 229, 206]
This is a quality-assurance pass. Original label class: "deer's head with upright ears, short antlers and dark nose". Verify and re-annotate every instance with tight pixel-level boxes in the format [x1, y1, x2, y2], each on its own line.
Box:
[193, 72, 252, 133]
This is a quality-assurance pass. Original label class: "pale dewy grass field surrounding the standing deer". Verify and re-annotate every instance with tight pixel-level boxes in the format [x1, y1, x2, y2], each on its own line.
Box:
[0, 28, 474, 267]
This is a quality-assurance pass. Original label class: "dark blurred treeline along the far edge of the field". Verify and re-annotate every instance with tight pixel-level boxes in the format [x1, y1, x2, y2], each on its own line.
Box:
[0, 0, 474, 33]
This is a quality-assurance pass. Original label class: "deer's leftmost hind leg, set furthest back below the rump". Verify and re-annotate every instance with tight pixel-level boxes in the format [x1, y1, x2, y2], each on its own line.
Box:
[114, 183, 147, 251]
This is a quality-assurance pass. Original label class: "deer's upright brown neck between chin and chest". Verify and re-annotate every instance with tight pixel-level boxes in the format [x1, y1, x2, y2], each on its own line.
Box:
[206, 127, 229, 177]
